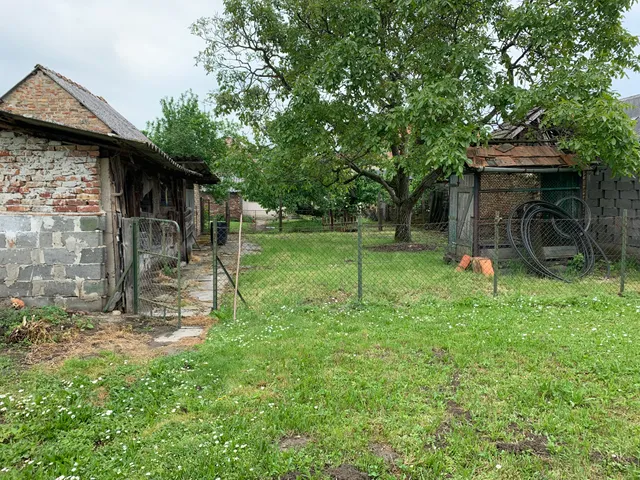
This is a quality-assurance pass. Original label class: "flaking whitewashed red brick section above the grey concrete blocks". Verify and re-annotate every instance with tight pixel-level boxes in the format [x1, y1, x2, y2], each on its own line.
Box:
[0, 127, 100, 213]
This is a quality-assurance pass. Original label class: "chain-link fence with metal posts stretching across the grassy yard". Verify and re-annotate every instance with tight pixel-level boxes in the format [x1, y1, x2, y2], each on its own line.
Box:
[208, 211, 640, 307]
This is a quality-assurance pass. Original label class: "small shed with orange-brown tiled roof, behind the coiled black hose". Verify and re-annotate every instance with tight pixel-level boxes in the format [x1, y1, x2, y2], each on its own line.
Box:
[448, 143, 583, 260]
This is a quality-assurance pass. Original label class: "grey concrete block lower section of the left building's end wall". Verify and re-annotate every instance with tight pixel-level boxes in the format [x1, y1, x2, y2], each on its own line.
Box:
[0, 214, 107, 311]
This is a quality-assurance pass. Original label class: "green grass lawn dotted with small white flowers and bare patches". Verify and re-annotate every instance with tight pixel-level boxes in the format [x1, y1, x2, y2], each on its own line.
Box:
[0, 228, 640, 479]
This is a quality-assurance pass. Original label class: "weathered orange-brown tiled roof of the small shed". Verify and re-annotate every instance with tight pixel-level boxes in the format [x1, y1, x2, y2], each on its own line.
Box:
[467, 144, 575, 169]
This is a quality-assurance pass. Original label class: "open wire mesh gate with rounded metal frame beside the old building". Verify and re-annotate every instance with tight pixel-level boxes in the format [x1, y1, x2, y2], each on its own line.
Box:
[133, 218, 182, 317]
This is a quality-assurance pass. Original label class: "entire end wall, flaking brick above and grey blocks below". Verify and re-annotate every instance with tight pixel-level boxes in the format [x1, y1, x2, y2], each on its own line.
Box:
[0, 129, 107, 311]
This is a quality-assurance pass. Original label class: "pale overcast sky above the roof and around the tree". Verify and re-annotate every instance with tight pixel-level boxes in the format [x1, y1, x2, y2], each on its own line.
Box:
[0, 0, 640, 128]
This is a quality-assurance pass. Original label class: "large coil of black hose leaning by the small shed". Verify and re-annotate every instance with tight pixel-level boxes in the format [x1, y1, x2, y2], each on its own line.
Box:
[507, 197, 610, 283]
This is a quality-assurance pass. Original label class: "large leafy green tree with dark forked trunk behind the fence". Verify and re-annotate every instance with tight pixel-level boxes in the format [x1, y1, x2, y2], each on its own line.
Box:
[192, 0, 640, 241]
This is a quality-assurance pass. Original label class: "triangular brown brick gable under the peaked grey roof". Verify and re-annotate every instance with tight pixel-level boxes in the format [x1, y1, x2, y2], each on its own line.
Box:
[0, 71, 111, 134]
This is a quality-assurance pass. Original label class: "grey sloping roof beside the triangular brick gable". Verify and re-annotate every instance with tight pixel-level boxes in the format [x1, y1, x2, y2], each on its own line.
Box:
[35, 65, 151, 143]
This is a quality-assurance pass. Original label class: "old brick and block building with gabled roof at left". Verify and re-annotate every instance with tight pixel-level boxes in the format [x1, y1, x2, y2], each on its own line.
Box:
[0, 65, 217, 310]
